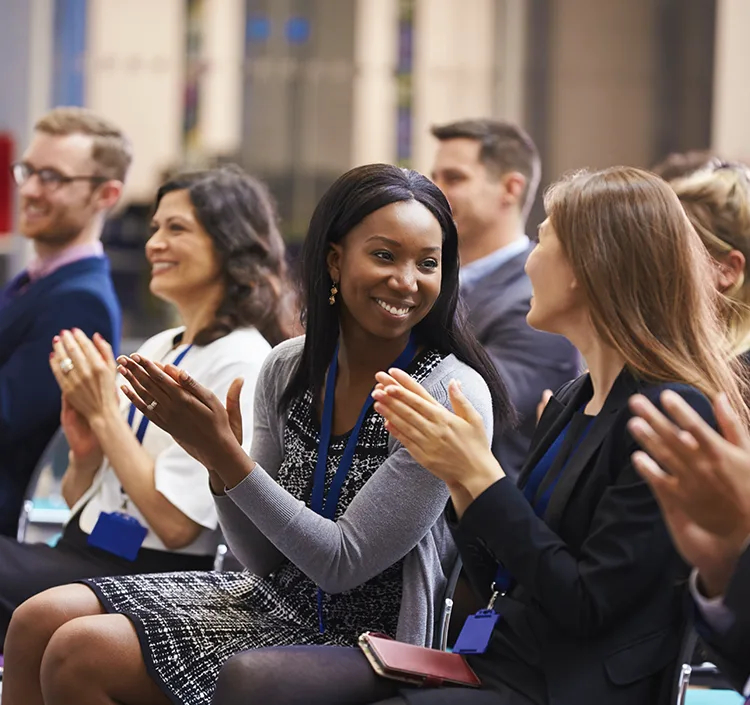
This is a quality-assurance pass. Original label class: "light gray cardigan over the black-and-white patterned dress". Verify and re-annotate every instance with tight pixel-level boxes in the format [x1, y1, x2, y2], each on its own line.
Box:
[216, 337, 493, 646]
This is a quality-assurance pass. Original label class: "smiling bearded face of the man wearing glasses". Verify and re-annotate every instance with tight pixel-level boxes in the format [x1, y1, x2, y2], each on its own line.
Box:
[19, 132, 111, 246]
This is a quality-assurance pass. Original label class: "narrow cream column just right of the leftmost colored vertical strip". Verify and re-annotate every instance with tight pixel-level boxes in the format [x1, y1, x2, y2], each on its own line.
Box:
[198, 0, 245, 154]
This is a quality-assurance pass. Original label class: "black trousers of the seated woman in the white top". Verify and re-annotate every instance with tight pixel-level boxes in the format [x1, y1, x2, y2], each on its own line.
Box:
[0, 516, 214, 651]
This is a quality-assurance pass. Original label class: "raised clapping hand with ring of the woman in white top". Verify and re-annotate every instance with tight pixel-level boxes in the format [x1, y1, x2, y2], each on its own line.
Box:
[50, 328, 120, 422]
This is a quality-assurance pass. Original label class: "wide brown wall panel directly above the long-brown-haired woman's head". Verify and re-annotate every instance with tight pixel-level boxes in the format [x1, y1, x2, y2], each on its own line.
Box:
[544, 0, 660, 181]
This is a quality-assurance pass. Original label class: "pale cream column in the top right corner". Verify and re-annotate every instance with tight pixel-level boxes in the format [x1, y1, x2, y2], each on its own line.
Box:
[711, 0, 750, 160]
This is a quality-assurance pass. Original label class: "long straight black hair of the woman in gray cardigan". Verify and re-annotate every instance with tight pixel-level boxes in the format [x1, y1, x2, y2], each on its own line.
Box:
[281, 164, 514, 433]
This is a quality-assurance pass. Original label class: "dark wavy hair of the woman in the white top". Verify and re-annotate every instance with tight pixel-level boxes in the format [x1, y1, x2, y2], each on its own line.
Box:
[155, 165, 296, 345]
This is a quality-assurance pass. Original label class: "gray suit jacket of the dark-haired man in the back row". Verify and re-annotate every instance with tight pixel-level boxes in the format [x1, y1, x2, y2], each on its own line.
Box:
[462, 246, 580, 480]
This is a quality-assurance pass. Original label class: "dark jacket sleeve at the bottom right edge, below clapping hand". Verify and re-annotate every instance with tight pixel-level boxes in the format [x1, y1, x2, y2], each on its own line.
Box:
[697, 548, 750, 692]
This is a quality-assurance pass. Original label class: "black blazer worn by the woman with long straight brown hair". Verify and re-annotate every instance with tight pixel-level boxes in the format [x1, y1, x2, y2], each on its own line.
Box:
[449, 371, 715, 705]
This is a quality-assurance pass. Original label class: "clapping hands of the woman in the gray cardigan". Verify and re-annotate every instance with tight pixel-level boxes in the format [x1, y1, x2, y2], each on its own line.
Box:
[117, 354, 247, 478]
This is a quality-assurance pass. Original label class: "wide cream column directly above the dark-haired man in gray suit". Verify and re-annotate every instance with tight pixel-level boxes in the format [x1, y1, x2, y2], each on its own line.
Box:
[412, 0, 496, 173]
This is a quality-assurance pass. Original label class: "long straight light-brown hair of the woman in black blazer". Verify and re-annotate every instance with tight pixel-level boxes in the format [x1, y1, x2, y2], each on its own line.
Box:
[544, 167, 748, 423]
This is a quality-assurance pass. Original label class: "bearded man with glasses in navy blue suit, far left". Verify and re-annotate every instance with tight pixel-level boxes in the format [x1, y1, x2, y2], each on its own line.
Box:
[0, 108, 126, 536]
